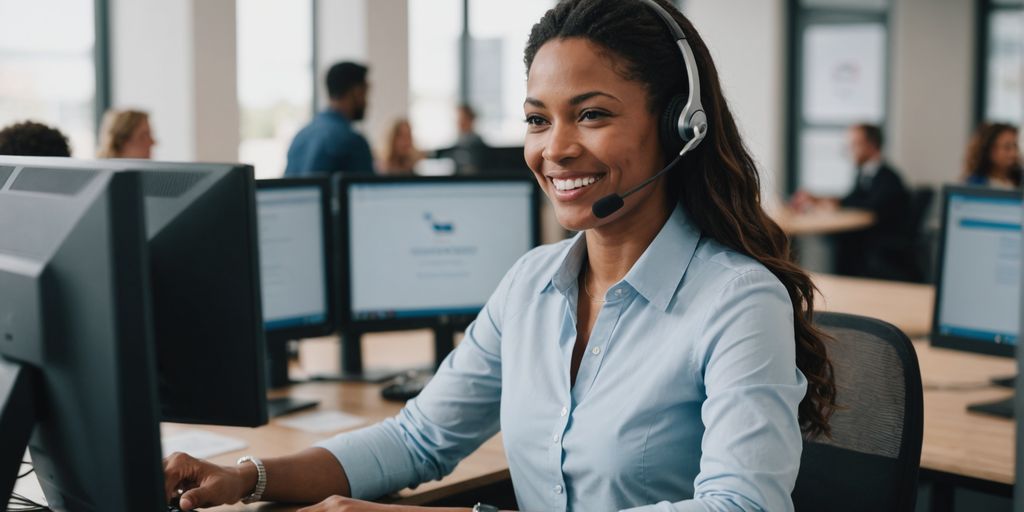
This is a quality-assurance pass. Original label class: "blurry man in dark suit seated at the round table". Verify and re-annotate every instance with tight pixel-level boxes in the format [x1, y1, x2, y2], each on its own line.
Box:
[793, 124, 910, 279]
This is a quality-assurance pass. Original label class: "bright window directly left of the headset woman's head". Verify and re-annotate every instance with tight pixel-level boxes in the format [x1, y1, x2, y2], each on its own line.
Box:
[409, 0, 555, 148]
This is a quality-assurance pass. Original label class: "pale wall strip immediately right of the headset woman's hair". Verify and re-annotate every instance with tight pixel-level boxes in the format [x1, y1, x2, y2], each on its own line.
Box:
[684, 0, 785, 207]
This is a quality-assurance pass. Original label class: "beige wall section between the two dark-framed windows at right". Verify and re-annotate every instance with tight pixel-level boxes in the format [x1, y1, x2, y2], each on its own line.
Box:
[887, 0, 976, 184]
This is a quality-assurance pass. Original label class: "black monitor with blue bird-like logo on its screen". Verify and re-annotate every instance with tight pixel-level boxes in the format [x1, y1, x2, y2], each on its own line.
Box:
[338, 173, 540, 374]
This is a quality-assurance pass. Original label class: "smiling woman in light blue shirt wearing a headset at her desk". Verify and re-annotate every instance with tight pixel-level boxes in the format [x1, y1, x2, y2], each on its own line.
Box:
[164, 0, 836, 512]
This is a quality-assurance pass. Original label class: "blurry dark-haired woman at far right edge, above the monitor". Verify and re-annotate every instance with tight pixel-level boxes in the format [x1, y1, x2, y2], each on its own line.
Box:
[964, 123, 1021, 188]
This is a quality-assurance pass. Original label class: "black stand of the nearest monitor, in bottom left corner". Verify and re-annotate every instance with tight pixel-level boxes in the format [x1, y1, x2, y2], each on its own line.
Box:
[0, 356, 36, 507]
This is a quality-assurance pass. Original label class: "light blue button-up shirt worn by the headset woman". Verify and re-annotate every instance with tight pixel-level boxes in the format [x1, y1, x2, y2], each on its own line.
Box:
[319, 207, 807, 512]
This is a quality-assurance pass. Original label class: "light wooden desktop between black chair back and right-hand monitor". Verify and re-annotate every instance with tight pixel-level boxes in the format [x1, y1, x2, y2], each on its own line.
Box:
[811, 273, 935, 338]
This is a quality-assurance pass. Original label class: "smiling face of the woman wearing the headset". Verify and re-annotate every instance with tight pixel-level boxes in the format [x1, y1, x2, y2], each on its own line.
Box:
[523, 38, 669, 230]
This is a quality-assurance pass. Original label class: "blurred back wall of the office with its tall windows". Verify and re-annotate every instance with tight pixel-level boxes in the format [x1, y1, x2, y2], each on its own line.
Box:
[0, 0, 1024, 192]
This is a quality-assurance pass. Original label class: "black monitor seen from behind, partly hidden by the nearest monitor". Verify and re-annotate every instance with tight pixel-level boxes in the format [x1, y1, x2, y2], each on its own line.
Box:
[116, 159, 267, 427]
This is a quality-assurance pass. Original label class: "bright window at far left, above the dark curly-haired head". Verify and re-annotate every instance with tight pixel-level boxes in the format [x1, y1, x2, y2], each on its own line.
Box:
[0, 0, 105, 158]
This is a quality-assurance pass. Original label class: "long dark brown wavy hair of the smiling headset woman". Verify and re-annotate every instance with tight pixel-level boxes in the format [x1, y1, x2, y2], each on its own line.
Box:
[524, 0, 836, 436]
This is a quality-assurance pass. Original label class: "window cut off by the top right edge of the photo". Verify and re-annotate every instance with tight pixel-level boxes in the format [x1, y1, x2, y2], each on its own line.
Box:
[979, 0, 1024, 125]
